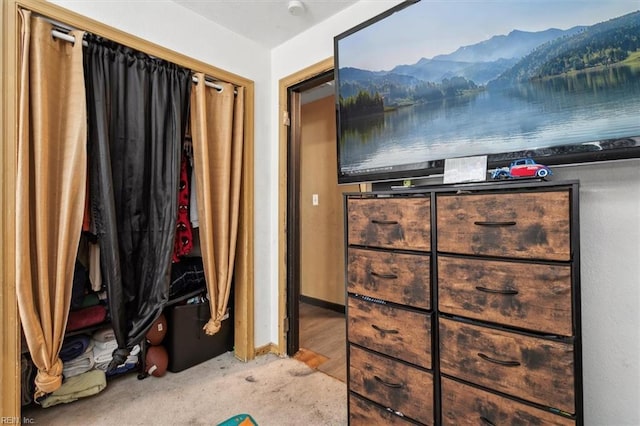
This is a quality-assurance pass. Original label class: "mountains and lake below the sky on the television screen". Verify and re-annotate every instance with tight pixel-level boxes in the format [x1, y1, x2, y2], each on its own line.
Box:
[336, 11, 640, 180]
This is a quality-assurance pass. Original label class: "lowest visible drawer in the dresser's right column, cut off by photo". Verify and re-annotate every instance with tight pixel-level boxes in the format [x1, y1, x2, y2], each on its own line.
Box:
[441, 377, 575, 426]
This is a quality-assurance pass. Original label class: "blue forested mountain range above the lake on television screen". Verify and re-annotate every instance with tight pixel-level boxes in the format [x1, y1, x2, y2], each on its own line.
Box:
[339, 11, 640, 107]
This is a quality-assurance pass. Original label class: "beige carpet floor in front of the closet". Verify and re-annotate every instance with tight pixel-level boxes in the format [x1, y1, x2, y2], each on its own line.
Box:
[22, 352, 347, 426]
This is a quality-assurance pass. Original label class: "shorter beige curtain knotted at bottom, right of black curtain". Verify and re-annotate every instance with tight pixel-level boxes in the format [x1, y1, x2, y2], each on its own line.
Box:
[191, 73, 244, 335]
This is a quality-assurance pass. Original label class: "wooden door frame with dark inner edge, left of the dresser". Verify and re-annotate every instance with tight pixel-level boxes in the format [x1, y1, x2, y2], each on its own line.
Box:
[278, 57, 334, 355]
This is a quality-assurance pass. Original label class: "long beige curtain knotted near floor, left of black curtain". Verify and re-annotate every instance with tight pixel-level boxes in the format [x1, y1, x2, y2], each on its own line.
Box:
[16, 11, 87, 398]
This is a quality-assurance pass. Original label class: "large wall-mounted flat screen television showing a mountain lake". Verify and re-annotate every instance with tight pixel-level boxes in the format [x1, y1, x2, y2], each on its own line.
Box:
[334, 0, 640, 183]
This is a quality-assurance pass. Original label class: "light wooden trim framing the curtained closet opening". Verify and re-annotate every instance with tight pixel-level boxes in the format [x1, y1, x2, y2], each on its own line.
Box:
[0, 0, 255, 418]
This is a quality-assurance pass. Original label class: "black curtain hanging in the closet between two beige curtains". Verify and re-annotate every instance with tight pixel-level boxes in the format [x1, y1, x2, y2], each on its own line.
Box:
[84, 35, 192, 369]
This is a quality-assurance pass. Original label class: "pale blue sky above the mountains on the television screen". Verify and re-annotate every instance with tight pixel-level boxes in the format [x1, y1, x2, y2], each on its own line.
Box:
[339, 0, 640, 71]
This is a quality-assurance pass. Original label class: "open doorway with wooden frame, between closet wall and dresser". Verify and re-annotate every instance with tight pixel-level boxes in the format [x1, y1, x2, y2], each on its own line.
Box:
[280, 61, 358, 380]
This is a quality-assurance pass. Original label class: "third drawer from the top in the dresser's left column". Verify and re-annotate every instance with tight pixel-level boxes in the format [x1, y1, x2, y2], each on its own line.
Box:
[347, 297, 431, 368]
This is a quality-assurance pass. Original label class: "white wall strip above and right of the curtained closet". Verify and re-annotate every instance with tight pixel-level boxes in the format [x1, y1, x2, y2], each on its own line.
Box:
[51, 0, 278, 347]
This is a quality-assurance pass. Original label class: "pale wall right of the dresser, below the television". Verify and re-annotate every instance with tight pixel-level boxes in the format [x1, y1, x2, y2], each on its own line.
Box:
[554, 160, 640, 426]
